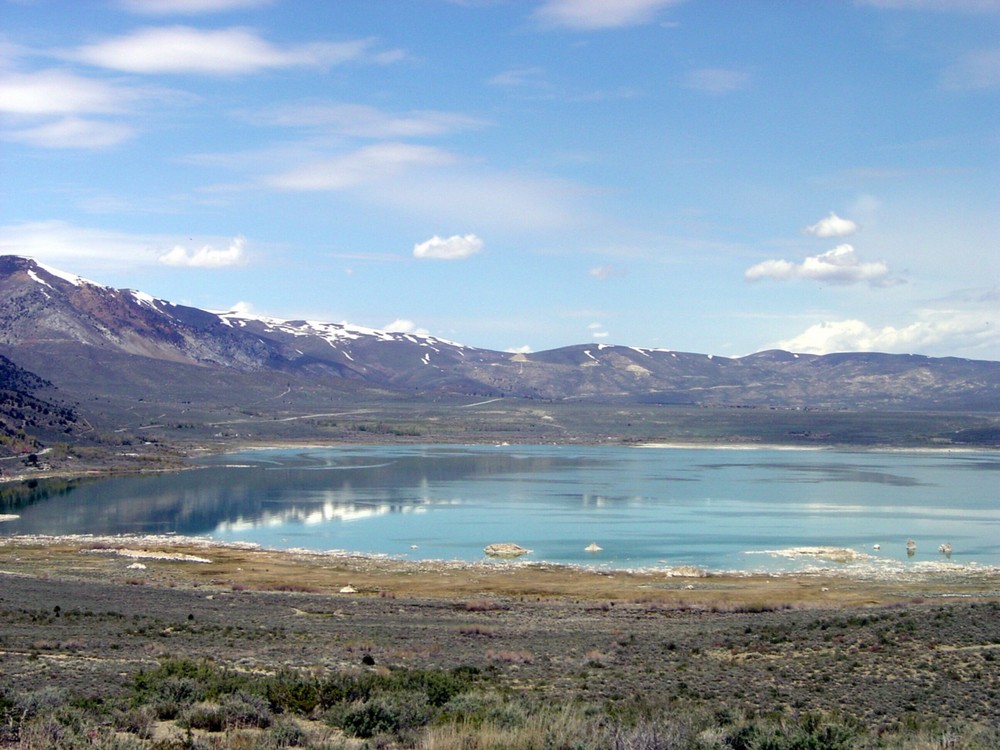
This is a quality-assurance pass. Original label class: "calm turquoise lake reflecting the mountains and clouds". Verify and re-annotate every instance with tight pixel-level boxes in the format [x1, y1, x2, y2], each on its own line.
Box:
[0, 446, 1000, 572]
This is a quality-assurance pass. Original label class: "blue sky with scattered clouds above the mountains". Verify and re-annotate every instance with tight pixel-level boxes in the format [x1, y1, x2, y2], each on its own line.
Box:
[0, 0, 1000, 360]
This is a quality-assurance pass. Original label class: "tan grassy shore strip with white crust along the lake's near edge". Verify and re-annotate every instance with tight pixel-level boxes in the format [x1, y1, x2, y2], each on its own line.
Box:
[0, 535, 1000, 609]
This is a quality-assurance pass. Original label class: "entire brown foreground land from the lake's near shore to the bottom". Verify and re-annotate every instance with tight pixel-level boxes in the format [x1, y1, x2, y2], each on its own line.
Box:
[0, 538, 1000, 749]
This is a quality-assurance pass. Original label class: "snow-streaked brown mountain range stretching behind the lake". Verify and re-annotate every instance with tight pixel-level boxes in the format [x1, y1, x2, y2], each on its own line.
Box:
[0, 256, 1000, 452]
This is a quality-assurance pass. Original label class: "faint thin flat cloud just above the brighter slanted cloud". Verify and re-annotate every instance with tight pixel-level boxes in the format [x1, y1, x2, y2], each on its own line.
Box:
[253, 104, 485, 140]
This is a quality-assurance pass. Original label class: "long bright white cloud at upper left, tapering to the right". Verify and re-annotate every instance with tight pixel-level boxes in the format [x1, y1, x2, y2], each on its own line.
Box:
[64, 26, 386, 75]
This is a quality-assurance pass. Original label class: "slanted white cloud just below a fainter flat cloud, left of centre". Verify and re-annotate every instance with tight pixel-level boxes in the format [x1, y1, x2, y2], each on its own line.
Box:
[267, 143, 454, 190]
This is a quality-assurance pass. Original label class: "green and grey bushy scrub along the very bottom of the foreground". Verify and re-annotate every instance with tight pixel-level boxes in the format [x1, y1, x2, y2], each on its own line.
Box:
[0, 658, 1000, 750]
